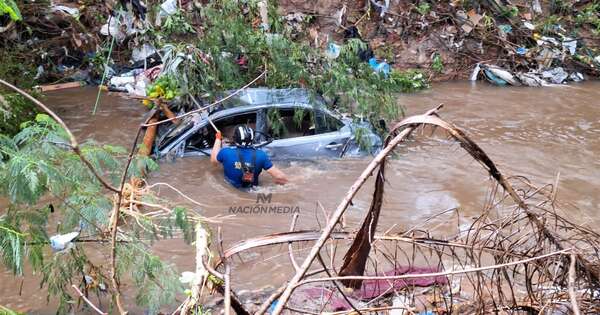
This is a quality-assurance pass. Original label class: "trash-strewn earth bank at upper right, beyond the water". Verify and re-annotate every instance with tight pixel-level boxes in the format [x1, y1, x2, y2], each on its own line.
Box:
[280, 0, 600, 86]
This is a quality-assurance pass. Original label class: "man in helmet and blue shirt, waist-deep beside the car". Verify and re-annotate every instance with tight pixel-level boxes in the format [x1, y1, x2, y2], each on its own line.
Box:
[210, 125, 288, 188]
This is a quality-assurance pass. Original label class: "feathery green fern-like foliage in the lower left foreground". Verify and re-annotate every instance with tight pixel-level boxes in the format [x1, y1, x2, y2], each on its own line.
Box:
[0, 114, 193, 314]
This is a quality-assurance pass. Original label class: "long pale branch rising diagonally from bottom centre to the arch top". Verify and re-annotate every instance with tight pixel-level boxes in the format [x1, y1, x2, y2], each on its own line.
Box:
[272, 106, 440, 315]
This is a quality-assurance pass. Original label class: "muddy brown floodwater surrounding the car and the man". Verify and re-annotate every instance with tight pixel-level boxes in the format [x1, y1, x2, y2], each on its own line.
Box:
[0, 82, 600, 313]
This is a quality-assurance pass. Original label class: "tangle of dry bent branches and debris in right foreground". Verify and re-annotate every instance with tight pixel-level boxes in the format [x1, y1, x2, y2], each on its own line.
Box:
[202, 109, 600, 314]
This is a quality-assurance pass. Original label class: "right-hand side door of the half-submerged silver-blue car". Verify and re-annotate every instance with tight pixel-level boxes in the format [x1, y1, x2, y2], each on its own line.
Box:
[264, 107, 352, 159]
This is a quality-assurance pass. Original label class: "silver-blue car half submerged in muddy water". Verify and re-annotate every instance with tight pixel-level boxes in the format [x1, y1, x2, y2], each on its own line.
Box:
[153, 88, 381, 159]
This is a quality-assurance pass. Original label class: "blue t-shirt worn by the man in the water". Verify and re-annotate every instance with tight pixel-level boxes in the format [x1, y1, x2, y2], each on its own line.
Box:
[217, 147, 273, 188]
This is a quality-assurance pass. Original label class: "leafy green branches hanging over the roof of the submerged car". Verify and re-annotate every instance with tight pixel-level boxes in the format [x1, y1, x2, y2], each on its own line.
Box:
[152, 0, 427, 131]
